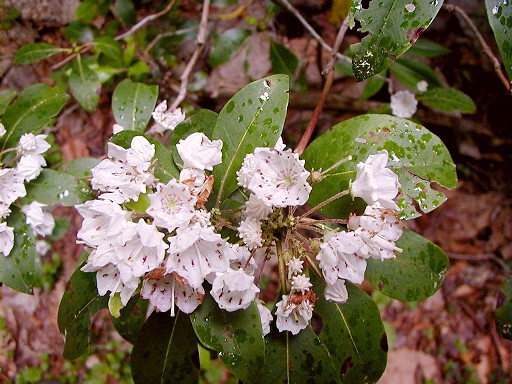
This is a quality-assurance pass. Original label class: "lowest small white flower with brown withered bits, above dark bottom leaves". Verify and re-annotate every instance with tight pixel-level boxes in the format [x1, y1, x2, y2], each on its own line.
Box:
[276, 295, 313, 335]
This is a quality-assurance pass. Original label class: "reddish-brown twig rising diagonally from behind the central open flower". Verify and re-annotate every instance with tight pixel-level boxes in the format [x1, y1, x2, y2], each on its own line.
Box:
[295, 16, 348, 155]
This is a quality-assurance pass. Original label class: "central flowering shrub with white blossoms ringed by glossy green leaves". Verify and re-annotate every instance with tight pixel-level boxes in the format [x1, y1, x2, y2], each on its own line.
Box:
[58, 75, 456, 383]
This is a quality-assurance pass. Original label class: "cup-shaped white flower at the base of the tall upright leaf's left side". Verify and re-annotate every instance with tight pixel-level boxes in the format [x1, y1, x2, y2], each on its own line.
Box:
[176, 132, 222, 171]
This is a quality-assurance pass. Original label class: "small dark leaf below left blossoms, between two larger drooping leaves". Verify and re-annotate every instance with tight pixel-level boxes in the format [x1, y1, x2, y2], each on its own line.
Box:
[112, 295, 148, 344]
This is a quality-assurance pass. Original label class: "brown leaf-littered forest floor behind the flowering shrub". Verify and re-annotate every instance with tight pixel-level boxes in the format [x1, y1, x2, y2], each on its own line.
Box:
[0, 0, 512, 384]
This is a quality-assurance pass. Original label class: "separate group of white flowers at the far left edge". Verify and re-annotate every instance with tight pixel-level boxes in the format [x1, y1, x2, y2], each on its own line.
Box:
[0, 123, 55, 256]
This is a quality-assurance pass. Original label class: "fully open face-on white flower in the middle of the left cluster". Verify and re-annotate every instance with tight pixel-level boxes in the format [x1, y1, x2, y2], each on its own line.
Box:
[146, 179, 197, 232]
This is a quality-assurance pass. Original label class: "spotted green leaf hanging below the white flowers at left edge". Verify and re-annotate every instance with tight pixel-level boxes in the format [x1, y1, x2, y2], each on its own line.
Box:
[0, 206, 39, 293]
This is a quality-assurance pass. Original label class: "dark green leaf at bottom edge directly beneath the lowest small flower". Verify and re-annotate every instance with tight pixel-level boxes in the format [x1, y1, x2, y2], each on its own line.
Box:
[262, 326, 341, 384]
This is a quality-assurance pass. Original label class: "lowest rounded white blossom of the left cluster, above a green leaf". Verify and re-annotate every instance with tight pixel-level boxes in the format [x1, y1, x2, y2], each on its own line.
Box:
[210, 269, 260, 312]
